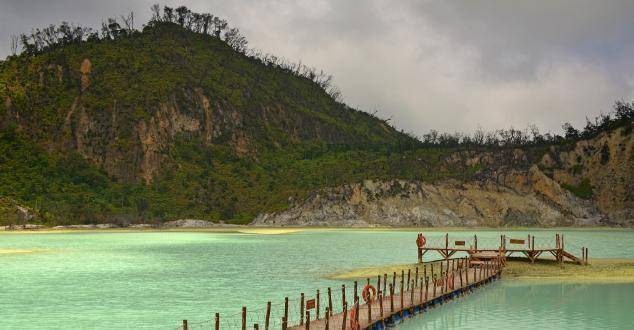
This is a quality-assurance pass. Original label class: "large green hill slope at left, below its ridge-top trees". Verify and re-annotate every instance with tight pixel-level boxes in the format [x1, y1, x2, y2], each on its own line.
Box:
[0, 18, 434, 224]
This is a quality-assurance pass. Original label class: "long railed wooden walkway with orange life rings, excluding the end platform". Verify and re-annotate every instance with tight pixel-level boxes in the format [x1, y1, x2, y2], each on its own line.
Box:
[178, 258, 501, 330]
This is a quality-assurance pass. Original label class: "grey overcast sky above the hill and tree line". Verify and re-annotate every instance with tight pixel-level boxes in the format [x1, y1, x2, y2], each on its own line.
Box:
[0, 0, 634, 135]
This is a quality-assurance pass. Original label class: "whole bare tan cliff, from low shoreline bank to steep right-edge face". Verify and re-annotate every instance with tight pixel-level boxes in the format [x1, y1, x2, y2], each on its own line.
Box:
[253, 128, 634, 226]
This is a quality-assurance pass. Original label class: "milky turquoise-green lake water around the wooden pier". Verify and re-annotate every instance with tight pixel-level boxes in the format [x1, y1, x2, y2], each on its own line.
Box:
[0, 230, 634, 329]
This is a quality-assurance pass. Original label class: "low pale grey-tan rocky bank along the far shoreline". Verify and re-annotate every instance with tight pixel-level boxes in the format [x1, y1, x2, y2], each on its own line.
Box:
[253, 178, 603, 226]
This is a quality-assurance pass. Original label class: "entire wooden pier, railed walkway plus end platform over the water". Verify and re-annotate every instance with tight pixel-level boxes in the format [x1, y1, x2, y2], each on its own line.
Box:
[178, 234, 588, 330]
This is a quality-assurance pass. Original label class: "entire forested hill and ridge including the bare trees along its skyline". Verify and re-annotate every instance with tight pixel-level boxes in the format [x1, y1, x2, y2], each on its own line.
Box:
[0, 7, 634, 225]
